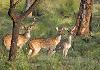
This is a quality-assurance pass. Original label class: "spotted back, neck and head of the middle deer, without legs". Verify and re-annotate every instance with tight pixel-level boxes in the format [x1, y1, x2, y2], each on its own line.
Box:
[29, 27, 67, 48]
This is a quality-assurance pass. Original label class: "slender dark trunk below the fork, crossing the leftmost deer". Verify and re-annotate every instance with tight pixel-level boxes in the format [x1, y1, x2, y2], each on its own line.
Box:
[9, 21, 19, 61]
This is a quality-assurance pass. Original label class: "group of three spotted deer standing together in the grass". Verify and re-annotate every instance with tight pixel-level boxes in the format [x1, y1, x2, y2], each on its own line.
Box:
[3, 20, 72, 57]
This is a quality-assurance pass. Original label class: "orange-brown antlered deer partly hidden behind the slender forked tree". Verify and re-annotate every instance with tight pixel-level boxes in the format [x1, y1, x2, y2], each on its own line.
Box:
[3, 22, 34, 50]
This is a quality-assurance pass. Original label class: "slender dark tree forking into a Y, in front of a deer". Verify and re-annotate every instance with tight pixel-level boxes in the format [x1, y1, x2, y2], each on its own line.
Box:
[8, 0, 39, 61]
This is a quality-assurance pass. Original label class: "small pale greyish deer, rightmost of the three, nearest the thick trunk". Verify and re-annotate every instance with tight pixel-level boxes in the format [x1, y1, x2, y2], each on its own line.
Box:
[55, 29, 73, 57]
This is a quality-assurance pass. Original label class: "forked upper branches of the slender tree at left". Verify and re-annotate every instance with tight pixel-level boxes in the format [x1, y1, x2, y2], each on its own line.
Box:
[8, 0, 39, 22]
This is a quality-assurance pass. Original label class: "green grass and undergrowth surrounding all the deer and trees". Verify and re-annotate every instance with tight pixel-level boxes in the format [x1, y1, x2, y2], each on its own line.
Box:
[0, 0, 100, 70]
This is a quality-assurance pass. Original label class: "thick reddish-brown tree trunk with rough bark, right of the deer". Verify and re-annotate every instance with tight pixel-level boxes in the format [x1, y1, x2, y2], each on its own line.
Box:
[71, 0, 93, 36]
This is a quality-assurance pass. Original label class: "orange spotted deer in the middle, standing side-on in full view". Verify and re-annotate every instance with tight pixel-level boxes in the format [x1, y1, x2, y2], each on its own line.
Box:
[28, 27, 66, 56]
